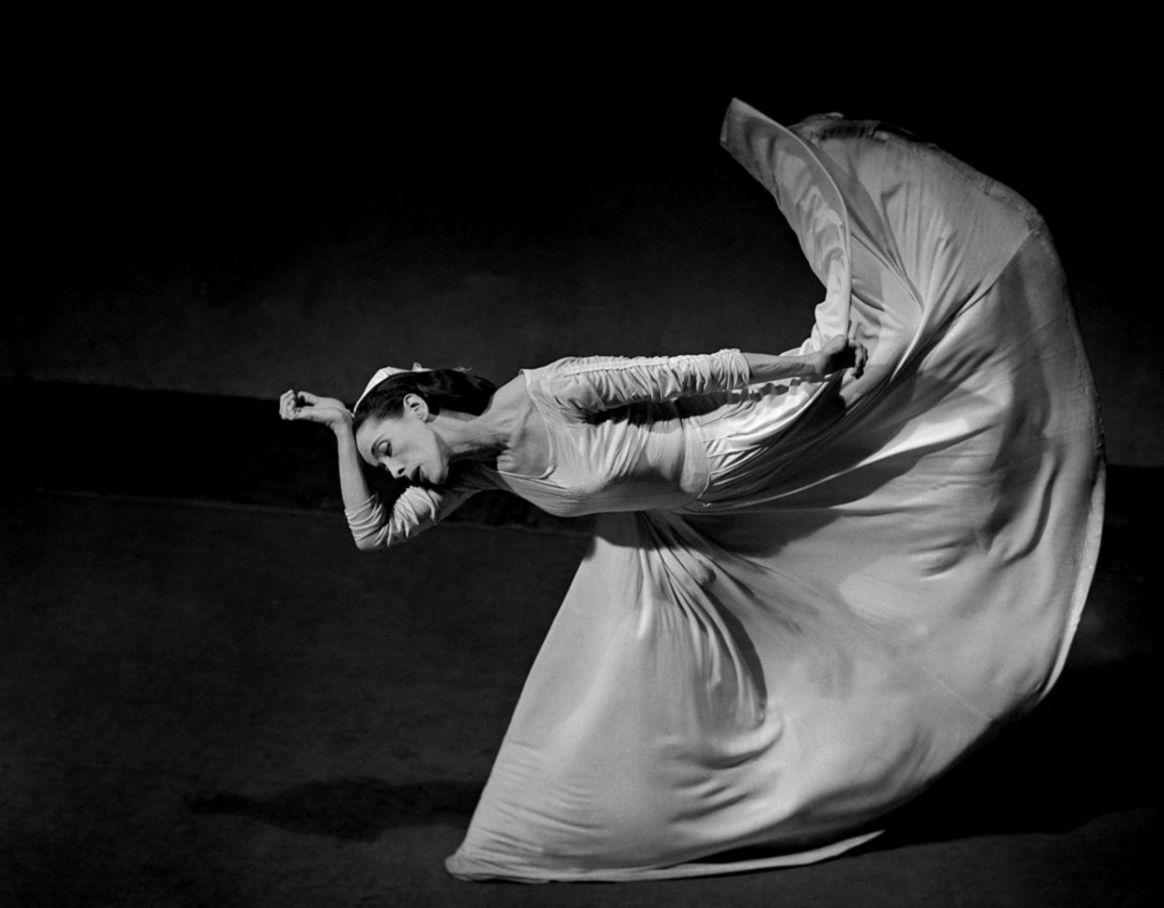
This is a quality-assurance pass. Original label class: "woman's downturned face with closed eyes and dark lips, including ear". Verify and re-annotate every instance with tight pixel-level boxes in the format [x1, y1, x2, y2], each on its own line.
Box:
[356, 395, 448, 485]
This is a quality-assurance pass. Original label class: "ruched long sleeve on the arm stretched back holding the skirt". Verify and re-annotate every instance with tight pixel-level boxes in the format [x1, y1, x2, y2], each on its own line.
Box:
[526, 349, 751, 419]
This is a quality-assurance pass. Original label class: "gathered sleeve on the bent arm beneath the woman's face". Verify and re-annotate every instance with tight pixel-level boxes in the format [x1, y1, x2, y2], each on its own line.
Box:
[343, 468, 492, 552]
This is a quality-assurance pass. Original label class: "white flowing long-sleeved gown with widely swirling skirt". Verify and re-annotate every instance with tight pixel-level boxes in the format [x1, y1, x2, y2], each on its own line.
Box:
[348, 101, 1102, 881]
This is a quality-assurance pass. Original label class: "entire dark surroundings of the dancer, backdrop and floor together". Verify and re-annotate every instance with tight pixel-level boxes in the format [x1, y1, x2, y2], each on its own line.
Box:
[0, 24, 1164, 908]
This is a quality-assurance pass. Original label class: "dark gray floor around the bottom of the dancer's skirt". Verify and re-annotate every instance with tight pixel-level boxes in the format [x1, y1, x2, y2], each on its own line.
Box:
[0, 492, 1159, 908]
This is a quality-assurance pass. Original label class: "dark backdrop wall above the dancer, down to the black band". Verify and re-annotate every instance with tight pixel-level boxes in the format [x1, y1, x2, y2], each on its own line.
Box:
[11, 31, 1164, 466]
